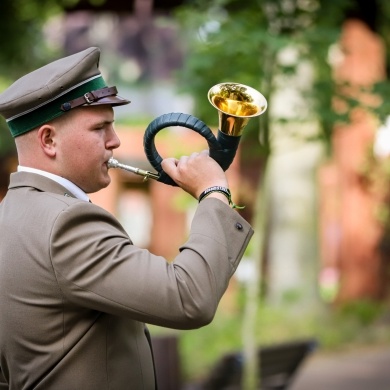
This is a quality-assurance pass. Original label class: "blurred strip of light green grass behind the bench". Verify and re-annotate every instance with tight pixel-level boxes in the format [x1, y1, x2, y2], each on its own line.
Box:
[152, 296, 390, 381]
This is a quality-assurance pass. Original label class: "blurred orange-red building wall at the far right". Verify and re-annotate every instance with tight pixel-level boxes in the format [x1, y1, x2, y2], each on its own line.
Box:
[319, 19, 389, 302]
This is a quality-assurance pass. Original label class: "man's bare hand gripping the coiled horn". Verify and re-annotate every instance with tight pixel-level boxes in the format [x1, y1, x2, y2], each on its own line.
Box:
[161, 150, 229, 201]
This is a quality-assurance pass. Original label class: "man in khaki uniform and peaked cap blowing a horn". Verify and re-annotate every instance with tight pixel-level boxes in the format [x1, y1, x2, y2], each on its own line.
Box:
[0, 48, 253, 390]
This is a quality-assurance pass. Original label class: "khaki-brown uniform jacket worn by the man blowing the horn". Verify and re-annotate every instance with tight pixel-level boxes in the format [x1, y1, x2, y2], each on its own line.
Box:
[0, 172, 253, 390]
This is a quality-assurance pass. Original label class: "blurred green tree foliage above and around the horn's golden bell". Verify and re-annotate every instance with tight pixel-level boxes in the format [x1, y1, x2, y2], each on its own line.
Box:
[176, 0, 390, 155]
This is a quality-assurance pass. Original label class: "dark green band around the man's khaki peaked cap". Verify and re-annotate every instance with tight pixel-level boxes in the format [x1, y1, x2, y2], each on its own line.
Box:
[7, 76, 107, 138]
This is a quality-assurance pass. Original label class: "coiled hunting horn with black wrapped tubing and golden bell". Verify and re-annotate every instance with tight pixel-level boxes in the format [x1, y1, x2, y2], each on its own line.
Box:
[108, 82, 267, 186]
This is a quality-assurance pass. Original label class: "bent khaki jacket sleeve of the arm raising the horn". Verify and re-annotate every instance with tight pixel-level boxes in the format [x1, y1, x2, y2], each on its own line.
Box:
[50, 198, 253, 329]
